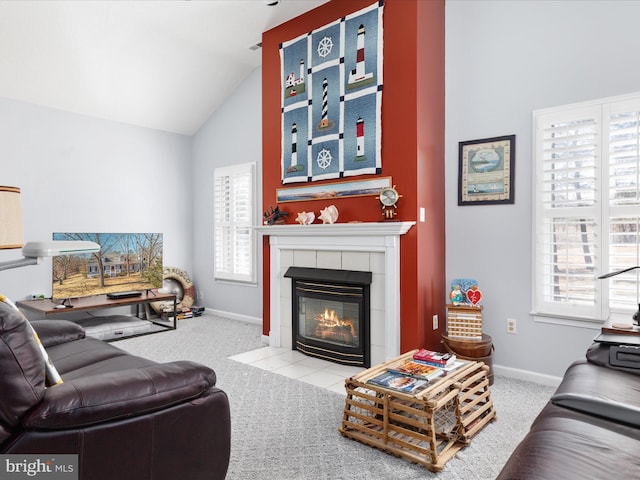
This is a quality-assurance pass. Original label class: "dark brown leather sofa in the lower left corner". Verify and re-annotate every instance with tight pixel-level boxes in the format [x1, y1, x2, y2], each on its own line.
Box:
[0, 302, 231, 480]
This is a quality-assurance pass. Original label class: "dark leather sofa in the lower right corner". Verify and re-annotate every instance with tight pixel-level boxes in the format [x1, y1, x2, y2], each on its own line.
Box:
[497, 343, 640, 480]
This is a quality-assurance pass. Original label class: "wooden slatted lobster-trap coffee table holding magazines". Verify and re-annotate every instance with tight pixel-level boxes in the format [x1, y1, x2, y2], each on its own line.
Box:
[338, 350, 496, 471]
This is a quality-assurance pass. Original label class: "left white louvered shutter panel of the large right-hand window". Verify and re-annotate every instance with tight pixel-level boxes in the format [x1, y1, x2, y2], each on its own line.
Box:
[536, 107, 601, 317]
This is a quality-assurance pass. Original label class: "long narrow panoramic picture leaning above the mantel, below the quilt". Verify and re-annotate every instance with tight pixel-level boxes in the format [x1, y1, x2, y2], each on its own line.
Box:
[276, 177, 391, 203]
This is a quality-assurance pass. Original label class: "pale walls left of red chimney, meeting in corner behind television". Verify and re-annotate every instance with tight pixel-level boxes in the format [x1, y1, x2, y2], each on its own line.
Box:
[0, 68, 262, 321]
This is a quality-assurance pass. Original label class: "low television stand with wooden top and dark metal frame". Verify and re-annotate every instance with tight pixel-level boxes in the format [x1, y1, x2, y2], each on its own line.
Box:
[16, 289, 177, 341]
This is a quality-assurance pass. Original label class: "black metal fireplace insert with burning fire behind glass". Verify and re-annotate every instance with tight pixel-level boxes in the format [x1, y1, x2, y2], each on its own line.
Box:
[284, 267, 372, 368]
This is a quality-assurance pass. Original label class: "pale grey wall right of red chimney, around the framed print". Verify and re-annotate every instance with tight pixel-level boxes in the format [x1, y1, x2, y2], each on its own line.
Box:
[445, 0, 640, 376]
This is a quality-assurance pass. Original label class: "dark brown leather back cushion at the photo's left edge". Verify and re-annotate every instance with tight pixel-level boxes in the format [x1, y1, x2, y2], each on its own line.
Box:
[0, 301, 45, 429]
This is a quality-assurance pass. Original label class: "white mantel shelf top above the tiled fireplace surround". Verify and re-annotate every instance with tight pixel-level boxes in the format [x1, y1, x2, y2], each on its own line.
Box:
[255, 222, 416, 237]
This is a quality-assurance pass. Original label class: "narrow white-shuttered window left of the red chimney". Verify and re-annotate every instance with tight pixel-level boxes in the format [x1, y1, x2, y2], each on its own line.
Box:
[214, 163, 256, 283]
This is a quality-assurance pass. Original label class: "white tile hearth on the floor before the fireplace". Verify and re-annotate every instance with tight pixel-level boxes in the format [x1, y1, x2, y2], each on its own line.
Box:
[229, 347, 364, 395]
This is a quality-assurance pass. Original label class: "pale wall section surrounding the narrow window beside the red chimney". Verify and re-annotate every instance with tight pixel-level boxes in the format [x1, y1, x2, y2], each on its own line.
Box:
[191, 68, 262, 323]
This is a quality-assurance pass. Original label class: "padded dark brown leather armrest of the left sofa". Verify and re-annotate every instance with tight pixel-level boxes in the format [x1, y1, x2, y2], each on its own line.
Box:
[22, 361, 216, 430]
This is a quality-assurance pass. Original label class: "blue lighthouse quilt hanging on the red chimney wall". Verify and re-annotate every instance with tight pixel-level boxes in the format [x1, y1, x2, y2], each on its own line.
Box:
[280, 1, 383, 184]
